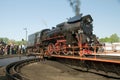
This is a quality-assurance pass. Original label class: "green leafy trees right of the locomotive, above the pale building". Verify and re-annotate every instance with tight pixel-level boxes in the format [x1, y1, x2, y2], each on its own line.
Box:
[100, 34, 120, 43]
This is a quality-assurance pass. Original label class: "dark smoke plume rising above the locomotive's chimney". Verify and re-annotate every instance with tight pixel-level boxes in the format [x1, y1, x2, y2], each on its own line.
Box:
[68, 0, 80, 15]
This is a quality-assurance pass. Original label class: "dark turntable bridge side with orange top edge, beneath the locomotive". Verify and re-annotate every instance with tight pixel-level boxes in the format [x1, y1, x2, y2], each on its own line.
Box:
[51, 55, 120, 79]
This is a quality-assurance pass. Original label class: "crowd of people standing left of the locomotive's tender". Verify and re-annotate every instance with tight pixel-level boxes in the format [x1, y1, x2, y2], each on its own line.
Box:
[0, 42, 25, 55]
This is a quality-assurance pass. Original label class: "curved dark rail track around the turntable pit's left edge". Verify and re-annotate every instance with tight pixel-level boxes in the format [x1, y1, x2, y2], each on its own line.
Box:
[6, 58, 39, 80]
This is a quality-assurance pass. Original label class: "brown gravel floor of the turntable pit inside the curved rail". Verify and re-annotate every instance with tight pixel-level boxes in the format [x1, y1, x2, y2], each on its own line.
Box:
[21, 61, 116, 80]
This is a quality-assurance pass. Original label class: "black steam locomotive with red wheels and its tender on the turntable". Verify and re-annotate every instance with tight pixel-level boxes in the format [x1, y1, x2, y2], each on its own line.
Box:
[27, 14, 100, 56]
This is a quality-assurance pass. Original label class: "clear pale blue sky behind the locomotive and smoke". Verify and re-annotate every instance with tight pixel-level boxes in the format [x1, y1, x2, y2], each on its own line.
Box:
[0, 0, 120, 41]
